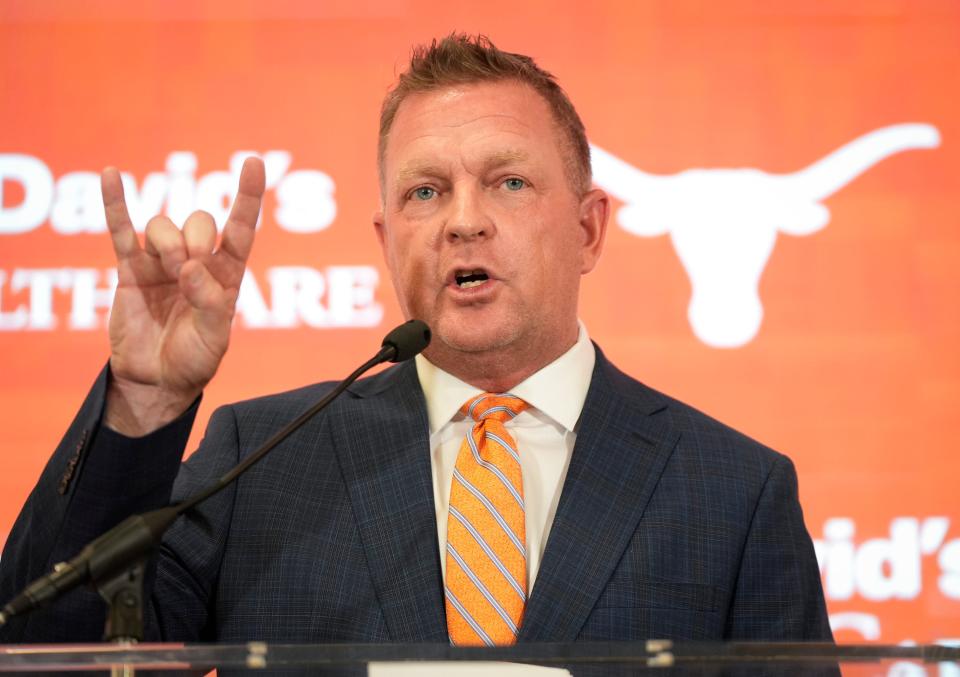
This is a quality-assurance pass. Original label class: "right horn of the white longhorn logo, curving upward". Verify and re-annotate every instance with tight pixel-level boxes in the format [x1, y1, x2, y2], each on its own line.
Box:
[784, 123, 940, 200]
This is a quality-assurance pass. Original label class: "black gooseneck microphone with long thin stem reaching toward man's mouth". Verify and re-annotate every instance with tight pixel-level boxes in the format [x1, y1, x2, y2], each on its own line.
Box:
[0, 320, 430, 625]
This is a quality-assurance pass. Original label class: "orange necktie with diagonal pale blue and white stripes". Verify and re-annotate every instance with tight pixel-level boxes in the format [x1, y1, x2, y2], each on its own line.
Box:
[446, 393, 530, 646]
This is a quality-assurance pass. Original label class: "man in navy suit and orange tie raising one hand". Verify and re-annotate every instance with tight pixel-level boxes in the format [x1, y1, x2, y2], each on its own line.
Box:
[0, 36, 830, 644]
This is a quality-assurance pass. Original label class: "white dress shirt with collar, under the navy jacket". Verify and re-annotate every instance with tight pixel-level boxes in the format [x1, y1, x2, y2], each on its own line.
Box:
[416, 323, 596, 594]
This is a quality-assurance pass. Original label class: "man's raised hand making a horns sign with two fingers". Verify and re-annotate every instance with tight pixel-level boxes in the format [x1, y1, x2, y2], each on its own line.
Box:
[101, 158, 264, 437]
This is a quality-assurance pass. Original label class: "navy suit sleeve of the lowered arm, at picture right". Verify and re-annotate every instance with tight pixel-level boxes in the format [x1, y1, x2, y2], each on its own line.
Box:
[724, 455, 833, 641]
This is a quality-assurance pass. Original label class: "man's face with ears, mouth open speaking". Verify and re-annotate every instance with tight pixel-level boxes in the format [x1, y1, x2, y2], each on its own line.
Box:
[374, 81, 607, 372]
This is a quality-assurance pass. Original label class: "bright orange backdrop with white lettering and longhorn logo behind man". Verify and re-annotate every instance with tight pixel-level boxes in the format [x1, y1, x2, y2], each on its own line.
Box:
[0, 0, 960, 642]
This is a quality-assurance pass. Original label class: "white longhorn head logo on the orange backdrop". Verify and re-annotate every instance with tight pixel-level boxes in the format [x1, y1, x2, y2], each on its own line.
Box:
[590, 124, 940, 348]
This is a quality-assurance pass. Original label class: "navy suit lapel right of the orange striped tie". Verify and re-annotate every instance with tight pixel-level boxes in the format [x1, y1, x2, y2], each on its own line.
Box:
[518, 349, 679, 642]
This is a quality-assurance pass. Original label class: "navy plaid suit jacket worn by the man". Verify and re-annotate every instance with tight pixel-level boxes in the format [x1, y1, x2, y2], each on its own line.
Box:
[0, 350, 831, 642]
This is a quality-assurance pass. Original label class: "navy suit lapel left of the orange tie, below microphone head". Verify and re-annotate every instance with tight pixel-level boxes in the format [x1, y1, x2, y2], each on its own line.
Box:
[331, 361, 447, 642]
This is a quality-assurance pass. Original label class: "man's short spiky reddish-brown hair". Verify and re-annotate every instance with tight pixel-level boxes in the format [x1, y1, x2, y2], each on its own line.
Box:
[377, 33, 592, 193]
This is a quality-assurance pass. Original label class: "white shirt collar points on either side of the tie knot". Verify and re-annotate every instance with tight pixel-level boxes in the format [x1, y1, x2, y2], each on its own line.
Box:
[416, 322, 596, 435]
